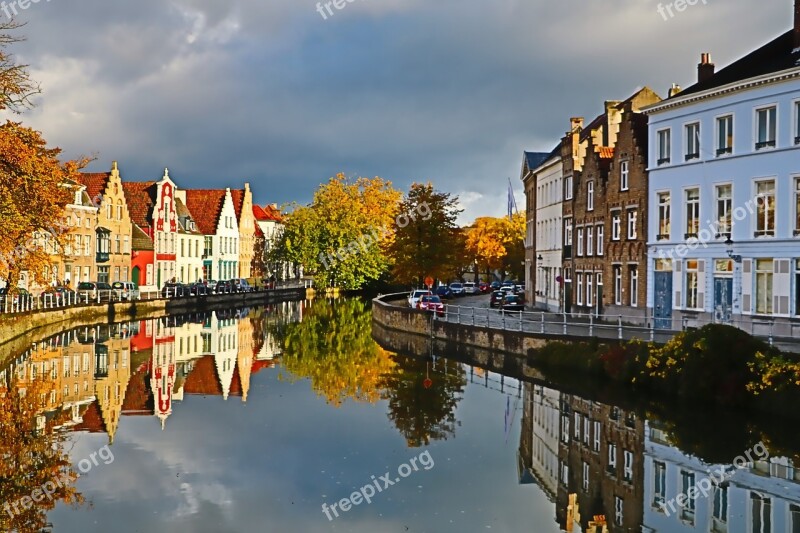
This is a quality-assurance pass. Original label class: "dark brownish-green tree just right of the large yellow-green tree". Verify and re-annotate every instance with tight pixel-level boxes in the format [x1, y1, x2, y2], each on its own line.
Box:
[389, 183, 464, 285]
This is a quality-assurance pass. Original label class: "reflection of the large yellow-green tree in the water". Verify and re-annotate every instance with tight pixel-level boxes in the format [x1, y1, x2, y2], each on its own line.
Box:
[273, 298, 394, 407]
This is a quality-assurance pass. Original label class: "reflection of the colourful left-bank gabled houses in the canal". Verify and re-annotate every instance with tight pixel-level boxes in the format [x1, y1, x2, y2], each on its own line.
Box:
[0, 302, 305, 443]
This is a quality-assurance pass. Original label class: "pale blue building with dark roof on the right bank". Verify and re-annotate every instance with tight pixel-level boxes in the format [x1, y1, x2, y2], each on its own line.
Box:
[644, 13, 800, 336]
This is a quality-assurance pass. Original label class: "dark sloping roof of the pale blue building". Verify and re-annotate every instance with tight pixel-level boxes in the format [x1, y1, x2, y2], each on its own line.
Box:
[670, 30, 800, 99]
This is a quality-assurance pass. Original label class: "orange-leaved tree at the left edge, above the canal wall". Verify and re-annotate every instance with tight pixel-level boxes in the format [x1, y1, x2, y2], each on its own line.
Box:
[0, 121, 88, 288]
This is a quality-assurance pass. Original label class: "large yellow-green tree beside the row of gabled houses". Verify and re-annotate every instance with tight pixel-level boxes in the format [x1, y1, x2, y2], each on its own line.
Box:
[270, 174, 402, 289]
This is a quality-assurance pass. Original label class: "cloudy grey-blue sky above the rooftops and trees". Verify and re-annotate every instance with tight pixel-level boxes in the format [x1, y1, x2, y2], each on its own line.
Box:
[0, 0, 793, 223]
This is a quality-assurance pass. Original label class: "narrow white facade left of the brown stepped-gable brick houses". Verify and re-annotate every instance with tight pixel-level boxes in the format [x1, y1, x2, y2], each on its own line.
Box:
[533, 154, 564, 312]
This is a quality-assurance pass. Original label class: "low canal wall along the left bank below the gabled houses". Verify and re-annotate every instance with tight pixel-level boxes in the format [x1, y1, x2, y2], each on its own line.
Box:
[0, 287, 313, 361]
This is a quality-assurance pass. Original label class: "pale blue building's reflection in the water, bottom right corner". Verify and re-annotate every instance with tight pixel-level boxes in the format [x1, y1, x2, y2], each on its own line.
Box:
[642, 424, 800, 533]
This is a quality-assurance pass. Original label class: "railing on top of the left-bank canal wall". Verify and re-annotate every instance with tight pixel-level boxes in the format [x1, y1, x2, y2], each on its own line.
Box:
[0, 279, 313, 315]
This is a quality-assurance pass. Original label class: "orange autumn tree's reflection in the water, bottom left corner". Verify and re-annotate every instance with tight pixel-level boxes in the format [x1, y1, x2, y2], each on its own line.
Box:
[0, 379, 84, 532]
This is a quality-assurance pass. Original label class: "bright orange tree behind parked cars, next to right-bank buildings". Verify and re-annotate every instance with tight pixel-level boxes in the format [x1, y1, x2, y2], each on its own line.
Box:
[466, 213, 525, 278]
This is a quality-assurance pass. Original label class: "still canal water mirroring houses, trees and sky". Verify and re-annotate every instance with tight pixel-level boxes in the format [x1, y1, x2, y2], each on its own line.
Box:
[0, 299, 800, 533]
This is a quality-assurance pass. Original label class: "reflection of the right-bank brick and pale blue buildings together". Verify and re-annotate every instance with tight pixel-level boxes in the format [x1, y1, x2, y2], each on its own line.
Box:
[519, 383, 800, 533]
